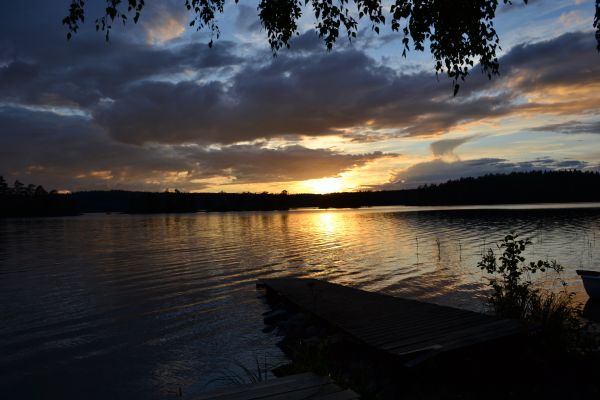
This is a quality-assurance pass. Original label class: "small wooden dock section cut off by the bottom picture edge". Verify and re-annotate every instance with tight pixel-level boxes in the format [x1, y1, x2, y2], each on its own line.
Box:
[195, 373, 359, 400]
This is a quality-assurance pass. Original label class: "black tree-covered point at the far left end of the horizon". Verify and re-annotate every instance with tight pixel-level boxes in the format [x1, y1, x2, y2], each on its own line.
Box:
[0, 176, 79, 217]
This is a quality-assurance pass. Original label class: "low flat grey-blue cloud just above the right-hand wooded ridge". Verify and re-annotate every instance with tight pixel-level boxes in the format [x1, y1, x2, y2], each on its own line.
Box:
[377, 157, 589, 190]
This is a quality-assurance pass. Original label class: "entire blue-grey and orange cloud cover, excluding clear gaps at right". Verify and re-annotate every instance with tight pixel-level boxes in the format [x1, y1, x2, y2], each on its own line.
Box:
[0, 0, 600, 189]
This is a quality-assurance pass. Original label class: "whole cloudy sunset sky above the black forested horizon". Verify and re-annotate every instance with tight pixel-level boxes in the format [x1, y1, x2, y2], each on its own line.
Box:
[0, 0, 600, 193]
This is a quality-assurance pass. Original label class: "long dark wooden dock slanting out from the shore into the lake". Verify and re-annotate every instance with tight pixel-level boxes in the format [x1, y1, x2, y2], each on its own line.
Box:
[258, 278, 522, 357]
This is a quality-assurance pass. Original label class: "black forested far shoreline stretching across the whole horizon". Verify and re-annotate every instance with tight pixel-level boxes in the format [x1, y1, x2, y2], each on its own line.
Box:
[0, 170, 600, 217]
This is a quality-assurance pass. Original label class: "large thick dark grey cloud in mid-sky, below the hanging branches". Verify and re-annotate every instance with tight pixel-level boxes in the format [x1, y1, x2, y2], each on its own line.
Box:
[96, 51, 404, 143]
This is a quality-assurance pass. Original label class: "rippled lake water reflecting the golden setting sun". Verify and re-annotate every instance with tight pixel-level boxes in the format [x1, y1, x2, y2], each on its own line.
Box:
[0, 204, 600, 400]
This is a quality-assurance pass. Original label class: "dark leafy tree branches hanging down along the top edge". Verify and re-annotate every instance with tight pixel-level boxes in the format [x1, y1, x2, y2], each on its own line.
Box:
[63, 0, 600, 95]
